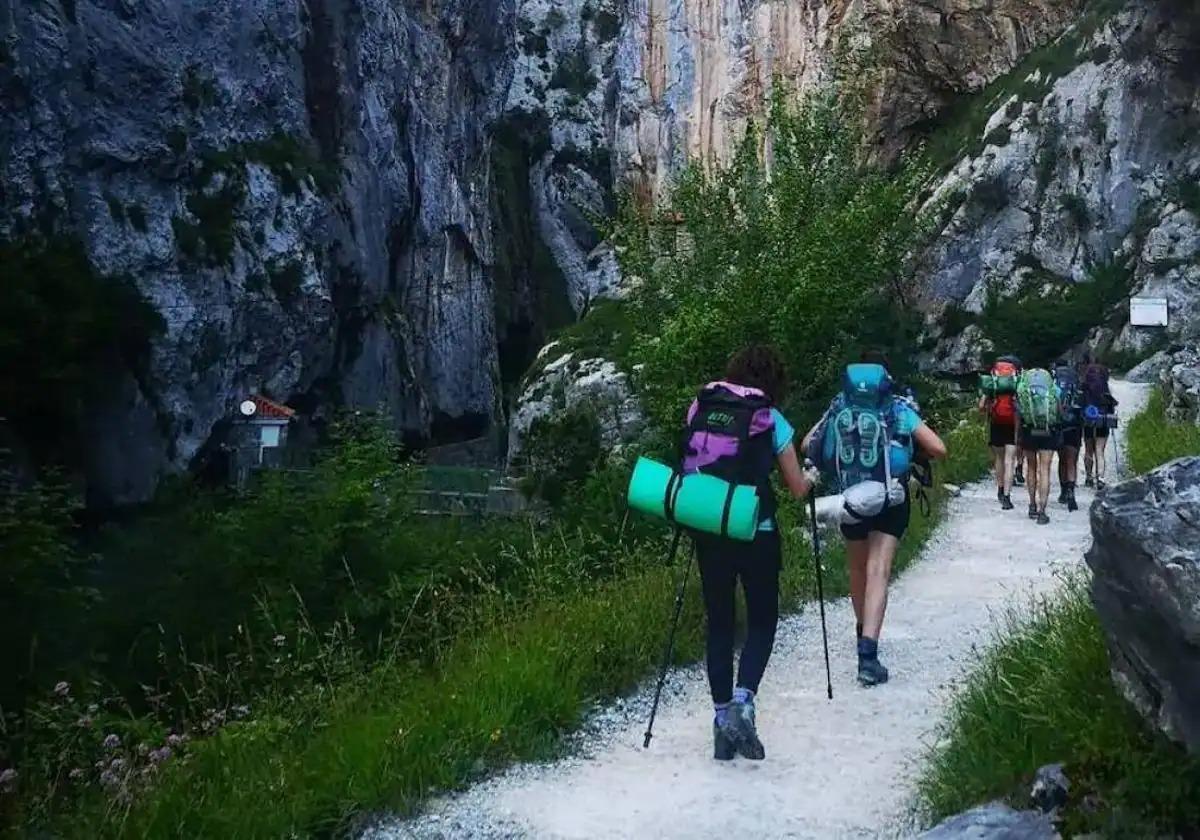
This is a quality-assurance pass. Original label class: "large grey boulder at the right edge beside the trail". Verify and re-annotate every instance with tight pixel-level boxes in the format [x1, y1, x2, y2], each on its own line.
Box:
[1087, 457, 1200, 752]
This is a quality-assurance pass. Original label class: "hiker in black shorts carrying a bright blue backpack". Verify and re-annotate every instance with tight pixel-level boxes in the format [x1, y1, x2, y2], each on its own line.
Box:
[803, 352, 946, 686]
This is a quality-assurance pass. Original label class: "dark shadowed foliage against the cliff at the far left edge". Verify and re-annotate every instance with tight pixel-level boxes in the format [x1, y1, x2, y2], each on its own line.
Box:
[0, 238, 164, 460]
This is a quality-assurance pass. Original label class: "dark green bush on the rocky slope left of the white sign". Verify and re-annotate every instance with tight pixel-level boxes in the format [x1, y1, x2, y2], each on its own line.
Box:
[979, 263, 1132, 366]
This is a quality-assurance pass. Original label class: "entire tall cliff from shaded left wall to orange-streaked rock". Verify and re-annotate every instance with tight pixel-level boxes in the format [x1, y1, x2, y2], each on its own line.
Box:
[0, 0, 1075, 502]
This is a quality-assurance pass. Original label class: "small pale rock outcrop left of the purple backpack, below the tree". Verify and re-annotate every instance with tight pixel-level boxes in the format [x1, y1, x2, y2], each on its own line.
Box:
[509, 344, 646, 470]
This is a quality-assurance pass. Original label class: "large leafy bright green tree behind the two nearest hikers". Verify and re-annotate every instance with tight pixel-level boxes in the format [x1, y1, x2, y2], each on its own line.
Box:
[614, 95, 925, 425]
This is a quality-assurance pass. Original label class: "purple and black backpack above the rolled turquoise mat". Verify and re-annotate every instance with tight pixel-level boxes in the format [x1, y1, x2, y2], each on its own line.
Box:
[682, 382, 776, 521]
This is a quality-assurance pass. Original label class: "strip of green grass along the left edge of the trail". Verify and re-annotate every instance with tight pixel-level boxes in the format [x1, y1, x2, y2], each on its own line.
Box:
[44, 417, 983, 838]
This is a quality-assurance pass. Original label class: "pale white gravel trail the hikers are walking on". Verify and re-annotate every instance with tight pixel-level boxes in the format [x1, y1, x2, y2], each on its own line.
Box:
[366, 382, 1148, 840]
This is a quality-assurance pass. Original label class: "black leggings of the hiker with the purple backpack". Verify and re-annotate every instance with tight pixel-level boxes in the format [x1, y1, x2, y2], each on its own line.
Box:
[696, 530, 782, 703]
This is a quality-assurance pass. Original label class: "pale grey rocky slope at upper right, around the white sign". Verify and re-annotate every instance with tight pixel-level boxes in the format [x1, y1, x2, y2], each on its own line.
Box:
[922, 0, 1200, 370]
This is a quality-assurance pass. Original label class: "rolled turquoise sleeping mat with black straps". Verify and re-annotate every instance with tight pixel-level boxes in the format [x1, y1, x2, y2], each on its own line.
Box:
[625, 457, 758, 542]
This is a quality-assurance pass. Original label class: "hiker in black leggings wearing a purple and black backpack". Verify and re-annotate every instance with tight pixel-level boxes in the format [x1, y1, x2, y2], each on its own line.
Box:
[683, 346, 817, 761]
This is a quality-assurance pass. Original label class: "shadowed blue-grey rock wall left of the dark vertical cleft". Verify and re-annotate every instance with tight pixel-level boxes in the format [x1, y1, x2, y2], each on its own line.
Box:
[0, 0, 514, 502]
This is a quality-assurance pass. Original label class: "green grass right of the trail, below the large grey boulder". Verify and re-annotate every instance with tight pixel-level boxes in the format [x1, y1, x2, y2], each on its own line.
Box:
[919, 580, 1200, 836]
